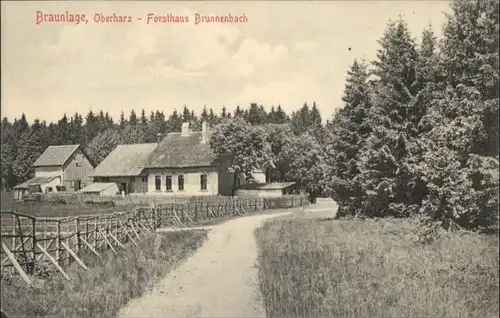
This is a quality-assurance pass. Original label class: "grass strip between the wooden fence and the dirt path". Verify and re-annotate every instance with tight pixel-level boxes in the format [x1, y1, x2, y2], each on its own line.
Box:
[1, 231, 207, 317]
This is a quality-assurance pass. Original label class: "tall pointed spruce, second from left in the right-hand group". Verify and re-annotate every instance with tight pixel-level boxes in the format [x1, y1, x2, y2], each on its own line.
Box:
[355, 20, 422, 216]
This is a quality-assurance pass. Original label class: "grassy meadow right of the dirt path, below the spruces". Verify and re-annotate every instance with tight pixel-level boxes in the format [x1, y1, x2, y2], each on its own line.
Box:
[256, 215, 499, 317]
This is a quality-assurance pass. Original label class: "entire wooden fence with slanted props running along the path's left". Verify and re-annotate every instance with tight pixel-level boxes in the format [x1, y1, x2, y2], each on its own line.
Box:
[0, 195, 309, 284]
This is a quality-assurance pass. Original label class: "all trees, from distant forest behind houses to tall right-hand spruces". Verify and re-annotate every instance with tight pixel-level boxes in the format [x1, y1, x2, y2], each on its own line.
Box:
[1, 0, 499, 230]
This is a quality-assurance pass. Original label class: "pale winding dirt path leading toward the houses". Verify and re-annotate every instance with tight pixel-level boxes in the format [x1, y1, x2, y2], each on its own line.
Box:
[118, 213, 287, 317]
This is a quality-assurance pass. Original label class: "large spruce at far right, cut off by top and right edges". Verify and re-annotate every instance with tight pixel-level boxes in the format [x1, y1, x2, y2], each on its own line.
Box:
[420, 0, 499, 229]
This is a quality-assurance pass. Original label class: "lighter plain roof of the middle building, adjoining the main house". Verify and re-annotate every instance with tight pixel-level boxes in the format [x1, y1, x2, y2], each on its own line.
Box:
[90, 143, 158, 177]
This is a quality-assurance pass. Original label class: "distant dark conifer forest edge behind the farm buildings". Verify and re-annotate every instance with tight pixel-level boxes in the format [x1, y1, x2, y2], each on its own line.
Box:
[1, 103, 321, 190]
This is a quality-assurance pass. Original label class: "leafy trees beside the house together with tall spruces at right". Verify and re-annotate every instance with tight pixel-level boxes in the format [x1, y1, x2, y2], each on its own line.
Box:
[211, 0, 499, 230]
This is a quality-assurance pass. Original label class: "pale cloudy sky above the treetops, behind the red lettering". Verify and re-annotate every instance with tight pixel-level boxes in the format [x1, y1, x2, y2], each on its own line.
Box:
[1, 0, 449, 122]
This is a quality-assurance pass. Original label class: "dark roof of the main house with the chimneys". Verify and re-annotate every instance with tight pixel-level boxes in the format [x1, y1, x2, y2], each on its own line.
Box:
[146, 132, 215, 168]
